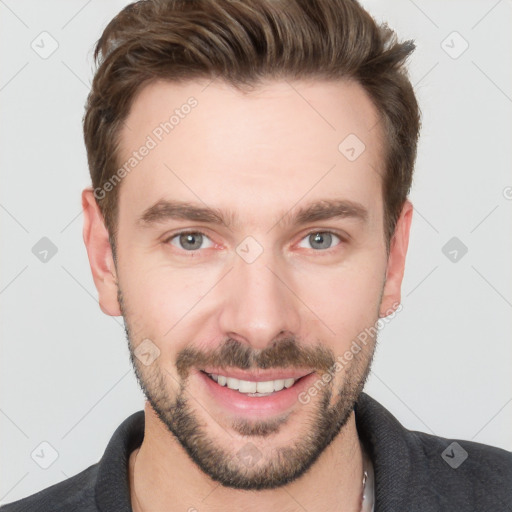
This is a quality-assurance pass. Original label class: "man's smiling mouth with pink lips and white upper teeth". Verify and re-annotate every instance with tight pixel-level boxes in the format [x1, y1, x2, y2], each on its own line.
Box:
[198, 369, 315, 418]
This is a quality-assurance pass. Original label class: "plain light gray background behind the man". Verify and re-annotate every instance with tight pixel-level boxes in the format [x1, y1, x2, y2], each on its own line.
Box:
[0, 0, 512, 503]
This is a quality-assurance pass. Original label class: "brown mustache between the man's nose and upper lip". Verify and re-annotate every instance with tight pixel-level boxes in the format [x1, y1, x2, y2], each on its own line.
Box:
[176, 338, 336, 379]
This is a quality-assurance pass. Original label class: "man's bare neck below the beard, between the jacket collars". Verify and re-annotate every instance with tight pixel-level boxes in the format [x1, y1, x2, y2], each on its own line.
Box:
[128, 403, 363, 512]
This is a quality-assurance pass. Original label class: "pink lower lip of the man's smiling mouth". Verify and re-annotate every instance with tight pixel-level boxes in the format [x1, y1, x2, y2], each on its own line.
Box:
[197, 372, 316, 418]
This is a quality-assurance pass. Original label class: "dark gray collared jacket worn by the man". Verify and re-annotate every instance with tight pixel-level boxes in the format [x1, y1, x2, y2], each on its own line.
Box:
[0, 393, 512, 512]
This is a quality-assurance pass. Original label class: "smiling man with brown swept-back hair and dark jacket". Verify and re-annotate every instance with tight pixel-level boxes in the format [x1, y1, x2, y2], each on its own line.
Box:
[3, 0, 512, 512]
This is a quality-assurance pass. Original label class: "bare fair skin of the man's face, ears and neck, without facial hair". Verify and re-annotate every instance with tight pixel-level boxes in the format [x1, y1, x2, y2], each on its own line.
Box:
[82, 77, 412, 512]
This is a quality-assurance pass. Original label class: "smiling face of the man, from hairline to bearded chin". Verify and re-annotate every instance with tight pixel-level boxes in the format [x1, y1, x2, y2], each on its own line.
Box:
[86, 78, 410, 489]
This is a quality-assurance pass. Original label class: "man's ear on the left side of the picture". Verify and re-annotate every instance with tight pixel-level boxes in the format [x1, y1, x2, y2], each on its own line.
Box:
[82, 188, 121, 316]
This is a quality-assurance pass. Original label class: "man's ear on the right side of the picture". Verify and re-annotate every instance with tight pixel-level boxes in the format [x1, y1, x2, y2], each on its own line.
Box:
[379, 200, 413, 318]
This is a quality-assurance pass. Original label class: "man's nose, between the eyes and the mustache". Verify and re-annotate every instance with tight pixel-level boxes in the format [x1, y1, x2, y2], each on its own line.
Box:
[219, 245, 301, 349]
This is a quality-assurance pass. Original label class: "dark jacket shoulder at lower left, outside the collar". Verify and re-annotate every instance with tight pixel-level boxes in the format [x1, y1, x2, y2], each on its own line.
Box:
[0, 464, 98, 512]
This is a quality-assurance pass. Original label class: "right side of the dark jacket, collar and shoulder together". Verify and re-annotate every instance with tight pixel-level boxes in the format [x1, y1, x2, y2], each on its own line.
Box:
[356, 393, 512, 511]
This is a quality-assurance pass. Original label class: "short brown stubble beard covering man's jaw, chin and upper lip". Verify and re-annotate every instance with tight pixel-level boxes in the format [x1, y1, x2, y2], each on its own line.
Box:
[118, 291, 376, 490]
